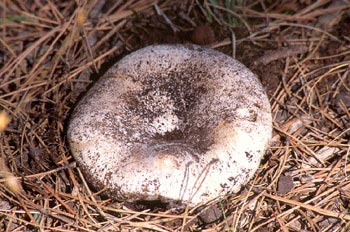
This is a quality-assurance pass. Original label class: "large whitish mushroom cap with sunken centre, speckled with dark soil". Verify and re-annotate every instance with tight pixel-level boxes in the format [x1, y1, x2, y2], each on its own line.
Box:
[67, 45, 272, 206]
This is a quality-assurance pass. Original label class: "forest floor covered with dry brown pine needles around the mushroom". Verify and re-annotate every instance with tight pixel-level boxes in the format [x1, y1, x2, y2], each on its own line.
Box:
[0, 0, 350, 232]
